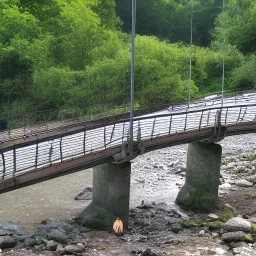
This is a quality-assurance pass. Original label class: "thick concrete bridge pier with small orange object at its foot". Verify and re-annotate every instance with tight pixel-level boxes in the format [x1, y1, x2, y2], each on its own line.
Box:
[77, 162, 131, 230]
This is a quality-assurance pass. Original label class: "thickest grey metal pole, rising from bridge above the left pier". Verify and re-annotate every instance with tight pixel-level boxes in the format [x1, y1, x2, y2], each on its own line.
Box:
[129, 0, 136, 156]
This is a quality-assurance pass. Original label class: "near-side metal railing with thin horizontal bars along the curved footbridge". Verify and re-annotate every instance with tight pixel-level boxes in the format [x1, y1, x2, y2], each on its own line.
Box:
[0, 94, 256, 184]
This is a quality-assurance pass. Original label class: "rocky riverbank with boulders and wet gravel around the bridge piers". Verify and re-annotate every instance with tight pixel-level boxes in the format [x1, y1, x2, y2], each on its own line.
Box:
[0, 134, 256, 256]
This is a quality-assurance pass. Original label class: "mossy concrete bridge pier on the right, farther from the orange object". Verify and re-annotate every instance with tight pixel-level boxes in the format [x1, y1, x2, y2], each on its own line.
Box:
[176, 142, 222, 211]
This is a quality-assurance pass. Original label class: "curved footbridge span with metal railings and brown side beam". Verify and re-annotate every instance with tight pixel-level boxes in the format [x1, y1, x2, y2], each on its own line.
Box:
[0, 93, 256, 193]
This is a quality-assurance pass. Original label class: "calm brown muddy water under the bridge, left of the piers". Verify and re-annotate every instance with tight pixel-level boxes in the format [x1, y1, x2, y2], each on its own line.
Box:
[0, 170, 92, 224]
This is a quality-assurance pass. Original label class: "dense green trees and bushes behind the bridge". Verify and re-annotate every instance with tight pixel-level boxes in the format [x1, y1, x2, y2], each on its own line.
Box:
[0, 0, 256, 117]
